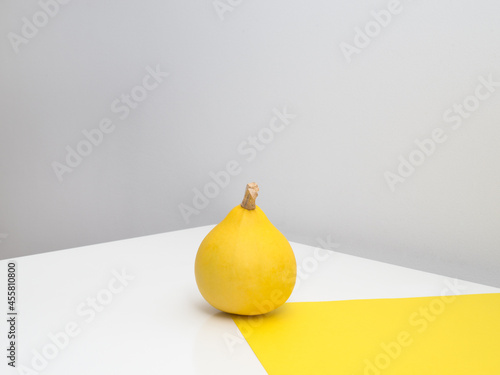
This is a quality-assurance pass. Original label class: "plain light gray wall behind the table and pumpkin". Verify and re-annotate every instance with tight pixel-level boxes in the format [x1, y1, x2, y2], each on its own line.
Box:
[0, 0, 500, 286]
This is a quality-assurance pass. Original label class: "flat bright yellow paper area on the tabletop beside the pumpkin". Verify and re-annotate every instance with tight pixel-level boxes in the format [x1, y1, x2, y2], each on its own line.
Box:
[233, 294, 500, 375]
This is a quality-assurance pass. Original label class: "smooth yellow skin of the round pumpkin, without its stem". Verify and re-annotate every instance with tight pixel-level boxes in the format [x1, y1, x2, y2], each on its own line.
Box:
[195, 206, 297, 315]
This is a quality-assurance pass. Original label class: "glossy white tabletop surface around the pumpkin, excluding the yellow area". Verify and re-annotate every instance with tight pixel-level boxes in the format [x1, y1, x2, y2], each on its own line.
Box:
[0, 226, 500, 375]
